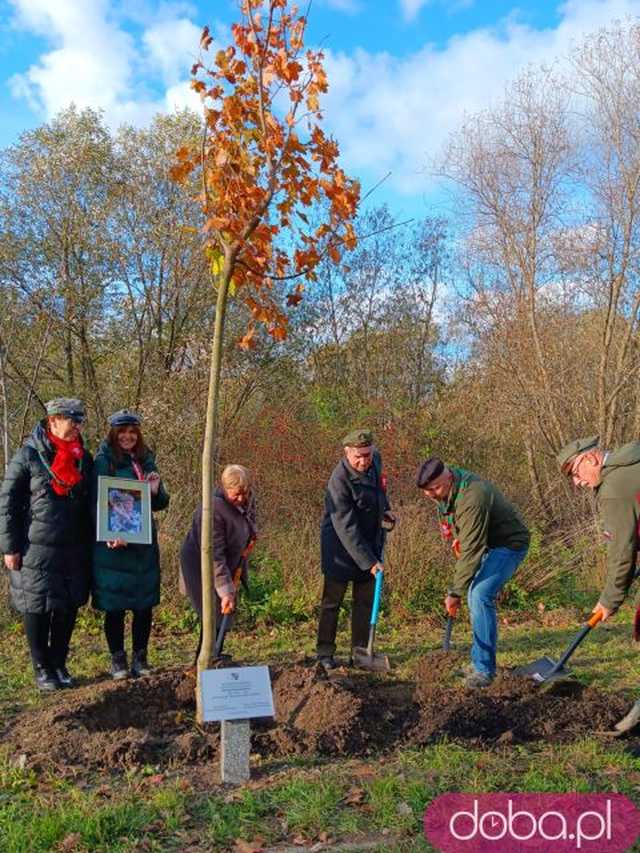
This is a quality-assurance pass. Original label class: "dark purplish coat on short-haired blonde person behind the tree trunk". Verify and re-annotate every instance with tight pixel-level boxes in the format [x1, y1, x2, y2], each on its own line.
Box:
[180, 489, 256, 617]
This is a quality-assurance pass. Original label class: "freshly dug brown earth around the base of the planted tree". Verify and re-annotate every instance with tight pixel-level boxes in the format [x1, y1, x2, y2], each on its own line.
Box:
[2, 653, 629, 775]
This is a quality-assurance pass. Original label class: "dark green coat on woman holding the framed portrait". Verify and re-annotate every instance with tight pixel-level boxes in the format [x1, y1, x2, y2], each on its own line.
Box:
[92, 441, 169, 610]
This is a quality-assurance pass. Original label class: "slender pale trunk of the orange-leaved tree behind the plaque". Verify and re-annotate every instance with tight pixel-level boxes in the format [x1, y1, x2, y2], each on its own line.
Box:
[196, 257, 232, 723]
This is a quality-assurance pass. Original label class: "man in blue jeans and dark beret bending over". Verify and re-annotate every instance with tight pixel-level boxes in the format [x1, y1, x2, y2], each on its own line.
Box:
[416, 456, 529, 688]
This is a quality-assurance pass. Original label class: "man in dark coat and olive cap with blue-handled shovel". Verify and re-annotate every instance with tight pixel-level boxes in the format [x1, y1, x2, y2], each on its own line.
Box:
[317, 430, 394, 670]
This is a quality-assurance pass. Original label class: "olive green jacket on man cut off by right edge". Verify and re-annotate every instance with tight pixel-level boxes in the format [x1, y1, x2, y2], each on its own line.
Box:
[596, 441, 640, 610]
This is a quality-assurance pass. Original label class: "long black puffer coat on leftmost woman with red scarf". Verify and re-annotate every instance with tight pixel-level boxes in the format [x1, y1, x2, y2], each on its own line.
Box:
[0, 422, 94, 613]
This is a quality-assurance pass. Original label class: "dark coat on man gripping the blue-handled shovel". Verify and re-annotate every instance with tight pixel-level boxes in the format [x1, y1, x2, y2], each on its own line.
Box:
[320, 452, 390, 582]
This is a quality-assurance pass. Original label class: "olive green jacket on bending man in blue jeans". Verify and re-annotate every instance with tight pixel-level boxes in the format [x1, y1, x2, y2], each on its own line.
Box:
[438, 468, 529, 596]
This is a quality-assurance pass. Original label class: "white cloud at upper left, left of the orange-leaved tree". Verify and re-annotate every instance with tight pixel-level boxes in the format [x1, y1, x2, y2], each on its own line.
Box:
[9, 0, 200, 125]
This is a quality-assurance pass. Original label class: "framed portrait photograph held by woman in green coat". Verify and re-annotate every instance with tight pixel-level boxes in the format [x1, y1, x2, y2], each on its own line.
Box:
[97, 477, 151, 545]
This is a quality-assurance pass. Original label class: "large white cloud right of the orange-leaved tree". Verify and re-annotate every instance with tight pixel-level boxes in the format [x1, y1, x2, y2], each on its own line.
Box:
[323, 0, 640, 195]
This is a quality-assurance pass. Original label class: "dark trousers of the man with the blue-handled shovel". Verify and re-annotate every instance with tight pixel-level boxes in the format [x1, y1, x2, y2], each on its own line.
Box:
[317, 574, 375, 657]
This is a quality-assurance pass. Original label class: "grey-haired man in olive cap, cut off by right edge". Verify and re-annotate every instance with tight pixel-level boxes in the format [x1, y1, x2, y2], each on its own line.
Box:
[557, 435, 640, 732]
